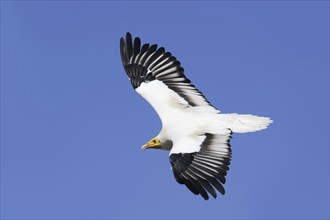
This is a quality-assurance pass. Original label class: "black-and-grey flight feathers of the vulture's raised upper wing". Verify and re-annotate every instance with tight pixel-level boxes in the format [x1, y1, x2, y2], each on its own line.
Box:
[120, 33, 215, 110]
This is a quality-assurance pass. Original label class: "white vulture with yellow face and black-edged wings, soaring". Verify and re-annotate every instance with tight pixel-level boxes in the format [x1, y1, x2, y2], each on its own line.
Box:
[120, 33, 272, 200]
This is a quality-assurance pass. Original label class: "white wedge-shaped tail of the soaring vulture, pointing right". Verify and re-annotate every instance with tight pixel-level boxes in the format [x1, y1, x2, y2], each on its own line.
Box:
[220, 114, 273, 133]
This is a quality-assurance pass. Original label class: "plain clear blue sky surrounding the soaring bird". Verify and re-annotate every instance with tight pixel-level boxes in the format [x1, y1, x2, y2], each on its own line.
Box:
[1, 1, 329, 219]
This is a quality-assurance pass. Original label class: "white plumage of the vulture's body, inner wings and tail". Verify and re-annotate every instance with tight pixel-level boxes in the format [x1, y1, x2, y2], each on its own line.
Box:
[136, 80, 271, 154]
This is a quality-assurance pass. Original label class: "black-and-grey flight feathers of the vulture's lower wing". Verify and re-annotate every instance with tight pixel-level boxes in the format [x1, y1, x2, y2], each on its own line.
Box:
[170, 133, 231, 200]
